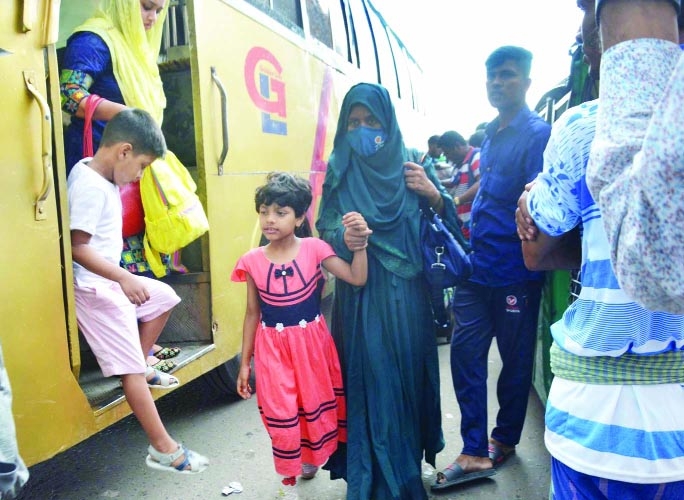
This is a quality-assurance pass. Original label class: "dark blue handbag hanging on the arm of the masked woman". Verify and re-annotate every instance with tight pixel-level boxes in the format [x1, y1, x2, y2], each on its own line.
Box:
[420, 207, 473, 330]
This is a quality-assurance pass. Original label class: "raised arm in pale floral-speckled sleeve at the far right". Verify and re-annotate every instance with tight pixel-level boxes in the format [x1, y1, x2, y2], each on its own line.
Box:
[587, 0, 684, 314]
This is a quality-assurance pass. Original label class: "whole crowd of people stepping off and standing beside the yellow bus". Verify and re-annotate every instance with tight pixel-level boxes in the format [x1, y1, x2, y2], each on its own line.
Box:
[6, 0, 684, 500]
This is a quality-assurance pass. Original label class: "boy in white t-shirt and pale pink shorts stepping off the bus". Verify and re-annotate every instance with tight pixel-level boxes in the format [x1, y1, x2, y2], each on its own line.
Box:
[68, 108, 209, 474]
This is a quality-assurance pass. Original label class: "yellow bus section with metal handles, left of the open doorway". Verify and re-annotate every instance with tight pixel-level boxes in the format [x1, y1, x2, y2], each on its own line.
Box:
[0, 0, 97, 465]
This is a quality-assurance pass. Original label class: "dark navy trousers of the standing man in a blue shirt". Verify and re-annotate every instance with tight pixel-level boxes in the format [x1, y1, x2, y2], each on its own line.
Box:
[451, 281, 541, 457]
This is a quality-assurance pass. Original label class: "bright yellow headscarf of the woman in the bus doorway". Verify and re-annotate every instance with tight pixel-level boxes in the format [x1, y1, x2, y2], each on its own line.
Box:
[74, 0, 171, 126]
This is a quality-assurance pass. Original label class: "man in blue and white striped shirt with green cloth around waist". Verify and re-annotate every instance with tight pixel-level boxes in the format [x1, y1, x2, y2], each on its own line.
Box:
[516, 0, 684, 500]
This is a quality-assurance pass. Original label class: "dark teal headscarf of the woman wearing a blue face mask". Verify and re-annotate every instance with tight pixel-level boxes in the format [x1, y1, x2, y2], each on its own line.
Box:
[317, 83, 421, 278]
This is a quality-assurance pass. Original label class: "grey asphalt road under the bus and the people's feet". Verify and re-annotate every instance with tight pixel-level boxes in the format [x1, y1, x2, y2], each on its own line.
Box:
[19, 339, 549, 500]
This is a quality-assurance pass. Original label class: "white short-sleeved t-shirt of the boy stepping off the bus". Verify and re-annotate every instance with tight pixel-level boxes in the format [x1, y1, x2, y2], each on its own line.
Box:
[67, 158, 123, 286]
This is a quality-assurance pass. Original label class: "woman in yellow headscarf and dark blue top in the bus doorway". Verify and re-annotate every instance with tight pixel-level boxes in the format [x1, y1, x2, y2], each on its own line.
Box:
[60, 0, 188, 372]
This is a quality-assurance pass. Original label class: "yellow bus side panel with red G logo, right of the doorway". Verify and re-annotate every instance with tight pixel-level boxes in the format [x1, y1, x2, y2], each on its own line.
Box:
[193, 0, 348, 364]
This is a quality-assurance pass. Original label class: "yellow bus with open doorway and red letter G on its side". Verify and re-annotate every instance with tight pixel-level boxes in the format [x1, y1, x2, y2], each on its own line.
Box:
[0, 0, 424, 465]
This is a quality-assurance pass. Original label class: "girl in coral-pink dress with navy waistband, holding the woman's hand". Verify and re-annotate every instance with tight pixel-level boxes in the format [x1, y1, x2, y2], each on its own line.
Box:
[231, 172, 372, 497]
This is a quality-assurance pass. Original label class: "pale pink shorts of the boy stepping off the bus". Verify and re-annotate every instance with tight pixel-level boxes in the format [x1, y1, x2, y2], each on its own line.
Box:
[74, 276, 181, 377]
